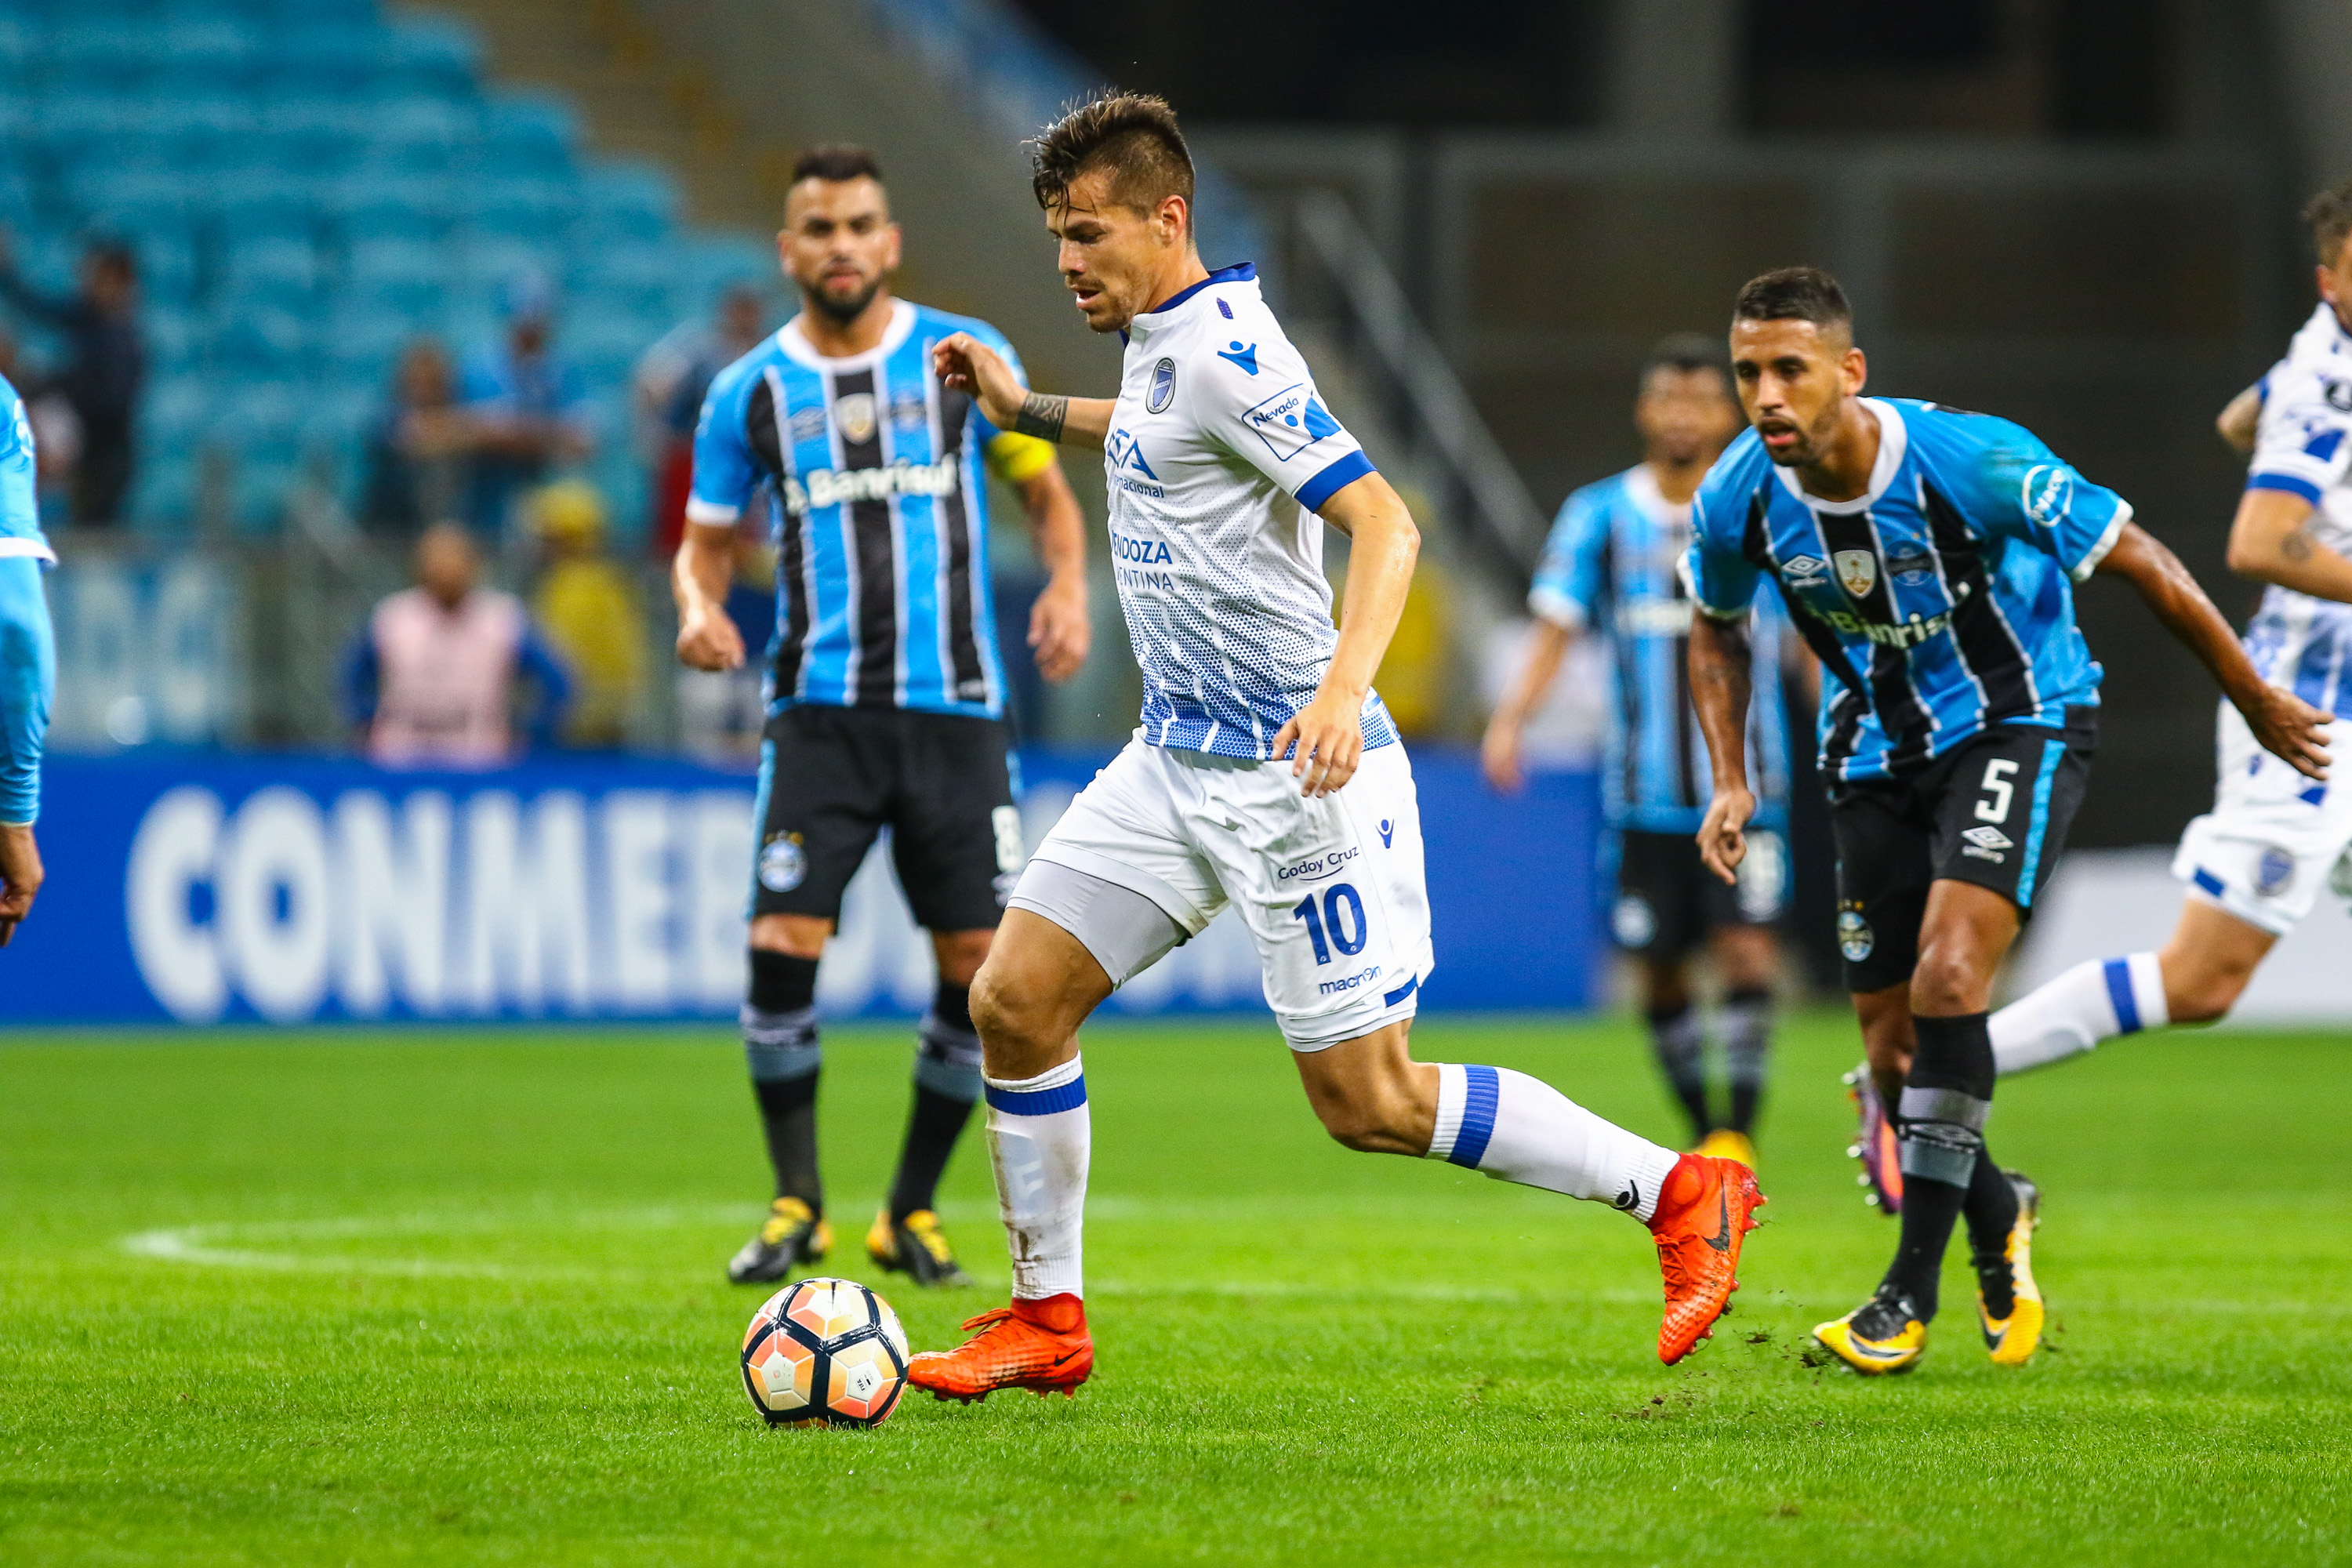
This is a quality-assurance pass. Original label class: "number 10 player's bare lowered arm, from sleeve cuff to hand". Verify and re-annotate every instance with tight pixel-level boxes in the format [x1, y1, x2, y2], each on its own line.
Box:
[1272, 473, 1421, 797]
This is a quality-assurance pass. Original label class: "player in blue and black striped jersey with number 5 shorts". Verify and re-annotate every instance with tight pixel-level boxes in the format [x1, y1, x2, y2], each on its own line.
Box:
[1689, 268, 2326, 1373]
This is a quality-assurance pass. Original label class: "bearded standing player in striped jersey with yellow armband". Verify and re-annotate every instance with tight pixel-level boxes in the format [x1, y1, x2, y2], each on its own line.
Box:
[675, 146, 1091, 1286]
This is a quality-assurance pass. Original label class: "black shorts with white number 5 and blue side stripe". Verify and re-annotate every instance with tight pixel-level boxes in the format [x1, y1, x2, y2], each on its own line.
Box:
[1830, 708, 2098, 992]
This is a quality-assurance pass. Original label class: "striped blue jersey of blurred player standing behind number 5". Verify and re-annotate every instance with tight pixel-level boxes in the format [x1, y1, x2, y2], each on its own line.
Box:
[1526, 463, 1788, 832]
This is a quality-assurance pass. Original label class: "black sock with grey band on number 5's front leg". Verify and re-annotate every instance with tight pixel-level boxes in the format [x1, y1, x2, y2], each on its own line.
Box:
[1882, 1013, 1992, 1323]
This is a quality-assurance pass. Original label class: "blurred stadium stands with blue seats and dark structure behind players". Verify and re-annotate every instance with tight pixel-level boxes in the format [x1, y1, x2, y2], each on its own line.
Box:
[13, 0, 2352, 1006]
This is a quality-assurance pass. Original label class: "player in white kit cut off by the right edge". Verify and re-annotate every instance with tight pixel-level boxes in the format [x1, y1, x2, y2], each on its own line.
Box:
[1992, 181, 2352, 1072]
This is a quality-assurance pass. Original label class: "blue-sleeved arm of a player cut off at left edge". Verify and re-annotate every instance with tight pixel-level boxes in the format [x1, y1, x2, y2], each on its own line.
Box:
[0, 364, 56, 947]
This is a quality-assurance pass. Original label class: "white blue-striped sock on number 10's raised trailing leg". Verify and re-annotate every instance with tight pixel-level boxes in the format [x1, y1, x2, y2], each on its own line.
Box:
[1428, 1062, 1682, 1220]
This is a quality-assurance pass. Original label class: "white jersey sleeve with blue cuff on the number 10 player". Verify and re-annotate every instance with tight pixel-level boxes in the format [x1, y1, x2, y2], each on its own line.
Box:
[1192, 326, 1371, 513]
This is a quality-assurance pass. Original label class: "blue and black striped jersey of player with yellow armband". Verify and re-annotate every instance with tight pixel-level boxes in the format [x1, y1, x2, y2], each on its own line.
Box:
[687, 301, 1054, 717]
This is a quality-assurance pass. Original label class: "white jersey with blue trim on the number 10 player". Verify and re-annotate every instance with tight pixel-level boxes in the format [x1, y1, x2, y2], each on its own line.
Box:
[1103, 263, 1397, 760]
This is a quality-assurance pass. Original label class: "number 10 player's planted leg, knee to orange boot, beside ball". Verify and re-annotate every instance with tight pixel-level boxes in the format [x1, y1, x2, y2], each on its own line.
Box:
[908, 907, 1110, 1399]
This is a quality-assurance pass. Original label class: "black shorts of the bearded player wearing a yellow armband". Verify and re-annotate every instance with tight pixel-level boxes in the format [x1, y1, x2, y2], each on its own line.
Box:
[750, 703, 1023, 931]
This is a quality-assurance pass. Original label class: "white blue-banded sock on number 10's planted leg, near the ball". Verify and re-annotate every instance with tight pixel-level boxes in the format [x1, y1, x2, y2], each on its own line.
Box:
[981, 1055, 1094, 1300]
